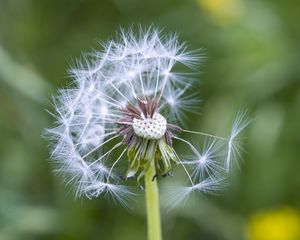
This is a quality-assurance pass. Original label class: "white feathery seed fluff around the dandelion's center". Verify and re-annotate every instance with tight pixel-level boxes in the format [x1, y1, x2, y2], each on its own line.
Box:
[47, 27, 247, 207]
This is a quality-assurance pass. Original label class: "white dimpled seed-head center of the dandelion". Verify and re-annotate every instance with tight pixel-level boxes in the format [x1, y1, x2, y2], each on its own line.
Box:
[132, 113, 167, 140]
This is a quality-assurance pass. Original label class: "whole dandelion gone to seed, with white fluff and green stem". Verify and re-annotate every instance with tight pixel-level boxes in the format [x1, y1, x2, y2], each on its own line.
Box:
[47, 27, 248, 239]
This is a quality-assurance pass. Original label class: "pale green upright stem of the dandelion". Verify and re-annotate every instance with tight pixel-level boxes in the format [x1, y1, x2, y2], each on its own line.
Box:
[145, 161, 162, 240]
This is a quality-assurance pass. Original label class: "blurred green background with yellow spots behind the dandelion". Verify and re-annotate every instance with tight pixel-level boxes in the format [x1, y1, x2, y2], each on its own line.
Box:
[0, 0, 300, 240]
